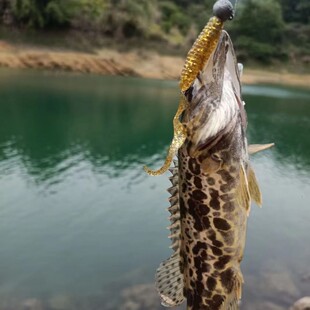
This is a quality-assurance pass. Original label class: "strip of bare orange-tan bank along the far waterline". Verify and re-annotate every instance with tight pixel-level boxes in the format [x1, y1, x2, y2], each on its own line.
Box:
[0, 41, 310, 89]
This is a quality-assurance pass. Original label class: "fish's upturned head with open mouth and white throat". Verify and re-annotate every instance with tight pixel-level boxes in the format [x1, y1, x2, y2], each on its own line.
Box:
[182, 31, 246, 157]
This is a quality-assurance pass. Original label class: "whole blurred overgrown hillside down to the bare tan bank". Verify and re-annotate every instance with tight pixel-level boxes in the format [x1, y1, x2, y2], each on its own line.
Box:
[0, 0, 310, 73]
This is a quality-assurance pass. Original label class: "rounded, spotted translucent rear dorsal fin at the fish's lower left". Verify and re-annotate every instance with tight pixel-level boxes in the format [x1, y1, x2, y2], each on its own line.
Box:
[156, 252, 184, 307]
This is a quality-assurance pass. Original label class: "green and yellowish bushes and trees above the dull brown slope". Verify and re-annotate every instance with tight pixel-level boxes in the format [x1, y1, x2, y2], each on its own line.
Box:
[0, 0, 310, 62]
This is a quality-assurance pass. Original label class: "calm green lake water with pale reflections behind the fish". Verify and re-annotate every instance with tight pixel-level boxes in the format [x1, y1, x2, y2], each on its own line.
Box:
[0, 71, 310, 310]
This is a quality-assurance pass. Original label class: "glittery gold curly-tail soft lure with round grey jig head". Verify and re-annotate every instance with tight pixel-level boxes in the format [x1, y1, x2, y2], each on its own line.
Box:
[144, 0, 233, 176]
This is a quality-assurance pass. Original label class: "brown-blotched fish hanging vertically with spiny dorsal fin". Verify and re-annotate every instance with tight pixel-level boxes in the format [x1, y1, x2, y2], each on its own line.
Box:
[156, 30, 273, 310]
